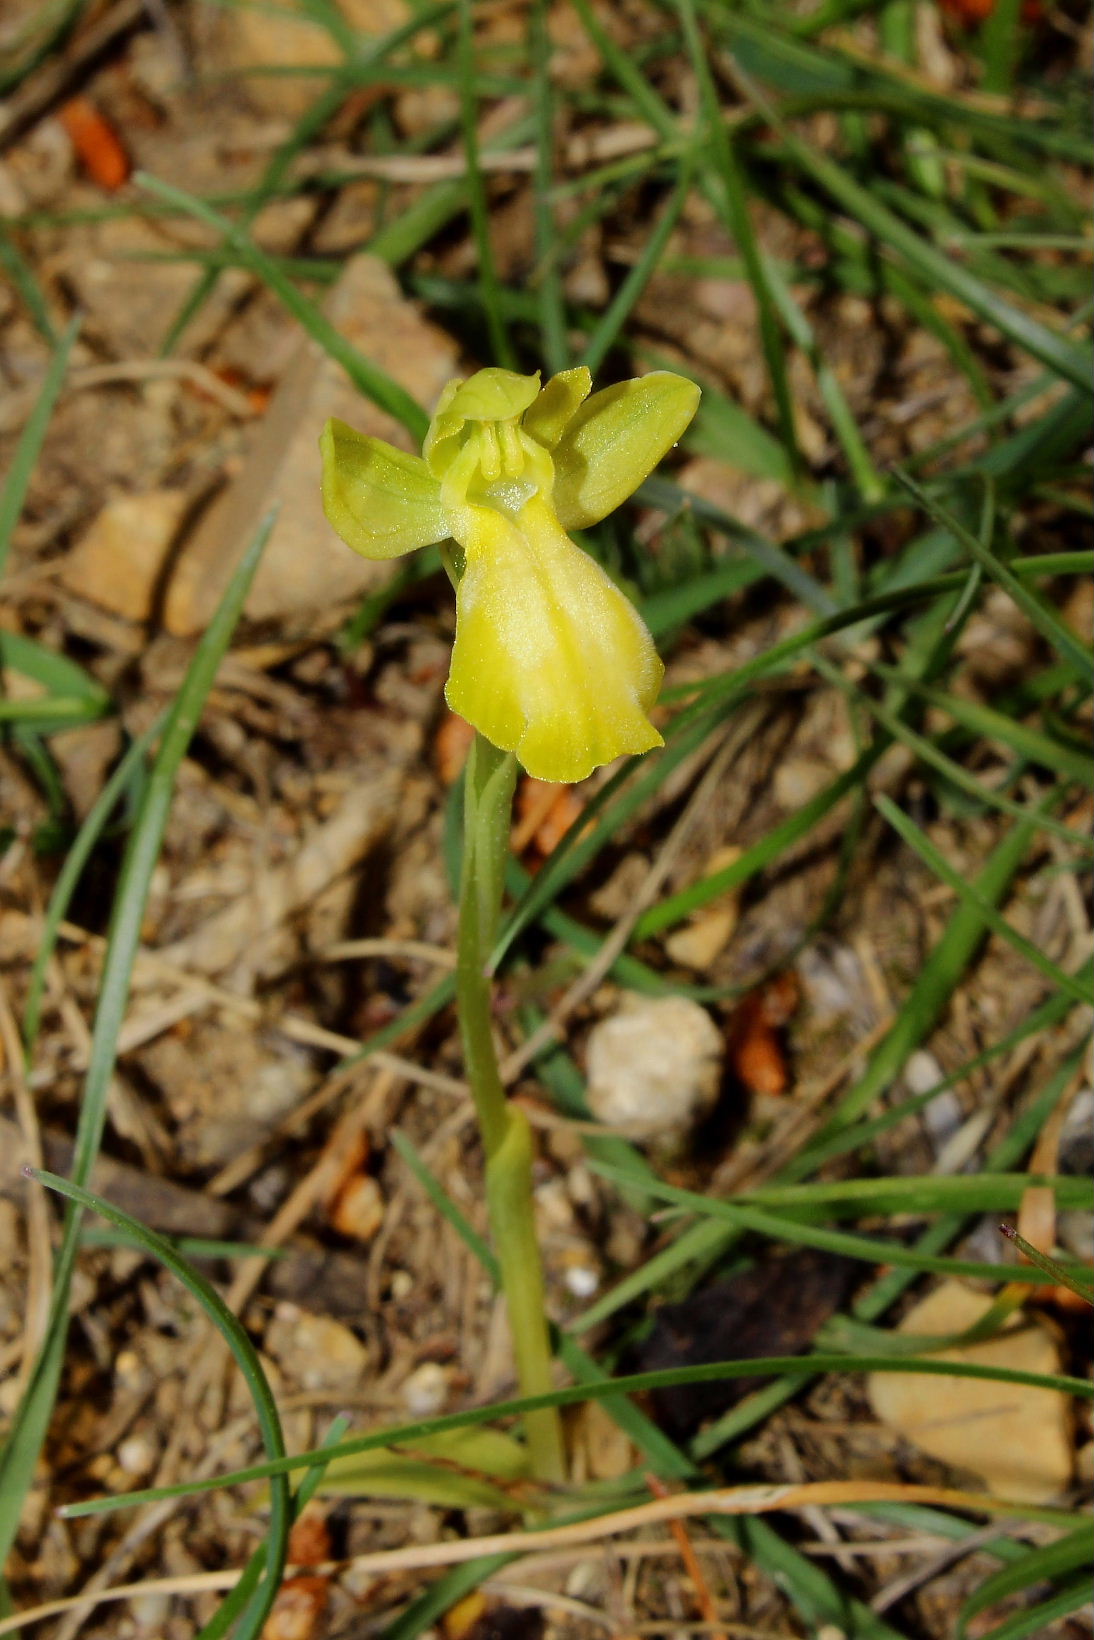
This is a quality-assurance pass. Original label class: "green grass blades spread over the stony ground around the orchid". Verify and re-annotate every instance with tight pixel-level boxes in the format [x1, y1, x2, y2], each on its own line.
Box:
[0, 0, 1094, 1640]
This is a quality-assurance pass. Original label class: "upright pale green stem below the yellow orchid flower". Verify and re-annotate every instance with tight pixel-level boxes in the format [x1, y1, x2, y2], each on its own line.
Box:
[456, 735, 566, 1481]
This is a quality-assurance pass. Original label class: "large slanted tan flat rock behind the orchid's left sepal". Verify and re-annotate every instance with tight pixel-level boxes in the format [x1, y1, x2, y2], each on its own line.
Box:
[164, 256, 458, 636]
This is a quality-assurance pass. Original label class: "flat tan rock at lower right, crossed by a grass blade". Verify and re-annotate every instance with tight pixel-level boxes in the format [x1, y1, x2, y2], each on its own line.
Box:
[868, 1281, 1074, 1504]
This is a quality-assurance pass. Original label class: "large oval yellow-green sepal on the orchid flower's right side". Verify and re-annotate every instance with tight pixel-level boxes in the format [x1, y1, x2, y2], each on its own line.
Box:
[553, 371, 699, 530]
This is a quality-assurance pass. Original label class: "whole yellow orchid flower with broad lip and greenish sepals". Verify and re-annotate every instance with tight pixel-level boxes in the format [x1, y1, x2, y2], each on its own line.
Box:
[320, 366, 699, 781]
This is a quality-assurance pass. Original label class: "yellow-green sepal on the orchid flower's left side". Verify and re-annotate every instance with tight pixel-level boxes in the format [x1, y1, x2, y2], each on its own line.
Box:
[320, 420, 448, 559]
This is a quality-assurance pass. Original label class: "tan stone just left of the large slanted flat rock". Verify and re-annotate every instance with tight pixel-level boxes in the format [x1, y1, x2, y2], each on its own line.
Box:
[61, 490, 187, 622]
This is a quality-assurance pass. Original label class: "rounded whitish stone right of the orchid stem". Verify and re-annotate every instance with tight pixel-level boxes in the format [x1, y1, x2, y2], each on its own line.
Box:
[587, 997, 723, 1140]
